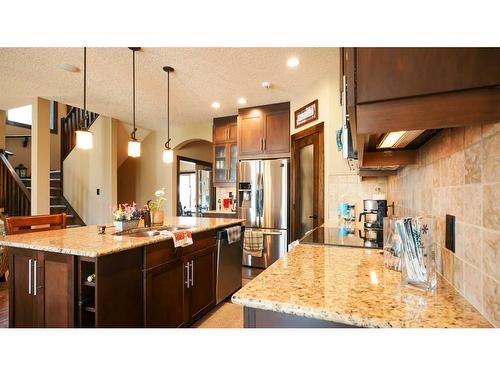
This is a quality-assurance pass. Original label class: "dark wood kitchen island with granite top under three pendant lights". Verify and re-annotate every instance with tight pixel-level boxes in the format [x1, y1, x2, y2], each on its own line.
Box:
[0, 217, 242, 327]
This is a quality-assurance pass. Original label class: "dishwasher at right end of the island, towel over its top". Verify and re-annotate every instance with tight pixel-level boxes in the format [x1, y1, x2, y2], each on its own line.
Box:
[216, 227, 244, 304]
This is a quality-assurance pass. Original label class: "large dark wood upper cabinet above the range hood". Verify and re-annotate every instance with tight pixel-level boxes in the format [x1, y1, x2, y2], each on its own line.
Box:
[340, 48, 500, 134]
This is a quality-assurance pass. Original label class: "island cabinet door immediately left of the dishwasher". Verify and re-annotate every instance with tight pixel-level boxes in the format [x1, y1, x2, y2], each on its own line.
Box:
[185, 246, 216, 322]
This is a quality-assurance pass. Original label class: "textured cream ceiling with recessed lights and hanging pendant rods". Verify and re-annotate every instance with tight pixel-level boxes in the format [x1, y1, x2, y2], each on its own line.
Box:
[0, 48, 338, 130]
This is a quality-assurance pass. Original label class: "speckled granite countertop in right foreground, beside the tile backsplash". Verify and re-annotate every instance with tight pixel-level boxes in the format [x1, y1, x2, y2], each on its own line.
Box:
[232, 244, 492, 328]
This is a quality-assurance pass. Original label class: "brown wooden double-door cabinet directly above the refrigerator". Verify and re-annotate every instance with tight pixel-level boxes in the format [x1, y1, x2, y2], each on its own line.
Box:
[238, 102, 290, 159]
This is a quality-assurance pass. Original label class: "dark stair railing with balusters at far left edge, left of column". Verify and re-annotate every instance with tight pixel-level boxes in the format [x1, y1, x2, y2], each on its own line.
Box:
[0, 150, 31, 216]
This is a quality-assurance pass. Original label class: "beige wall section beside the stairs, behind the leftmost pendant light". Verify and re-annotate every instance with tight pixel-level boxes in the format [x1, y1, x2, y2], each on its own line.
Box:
[63, 116, 117, 225]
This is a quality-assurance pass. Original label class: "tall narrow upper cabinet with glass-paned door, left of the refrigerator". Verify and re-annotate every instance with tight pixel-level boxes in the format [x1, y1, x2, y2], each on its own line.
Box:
[213, 116, 238, 187]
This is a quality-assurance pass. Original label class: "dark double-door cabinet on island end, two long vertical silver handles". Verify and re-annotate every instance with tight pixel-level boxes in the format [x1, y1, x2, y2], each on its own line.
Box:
[9, 248, 75, 328]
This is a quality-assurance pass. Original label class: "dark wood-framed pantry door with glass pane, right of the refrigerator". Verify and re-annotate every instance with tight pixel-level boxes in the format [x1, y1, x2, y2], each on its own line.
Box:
[291, 123, 324, 240]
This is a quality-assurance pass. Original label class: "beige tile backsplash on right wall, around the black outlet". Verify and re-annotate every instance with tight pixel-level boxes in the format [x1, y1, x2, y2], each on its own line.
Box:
[386, 123, 500, 327]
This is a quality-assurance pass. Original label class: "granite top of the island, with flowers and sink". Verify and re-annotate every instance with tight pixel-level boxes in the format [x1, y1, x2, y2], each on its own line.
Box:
[0, 217, 244, 257]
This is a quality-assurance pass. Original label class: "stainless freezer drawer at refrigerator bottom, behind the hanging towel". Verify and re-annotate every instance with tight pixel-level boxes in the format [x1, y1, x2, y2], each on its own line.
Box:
[243, 228, 288, 268]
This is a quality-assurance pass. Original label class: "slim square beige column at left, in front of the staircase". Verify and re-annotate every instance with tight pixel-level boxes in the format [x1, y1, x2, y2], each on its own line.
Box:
[31, 98, 50, 215]
